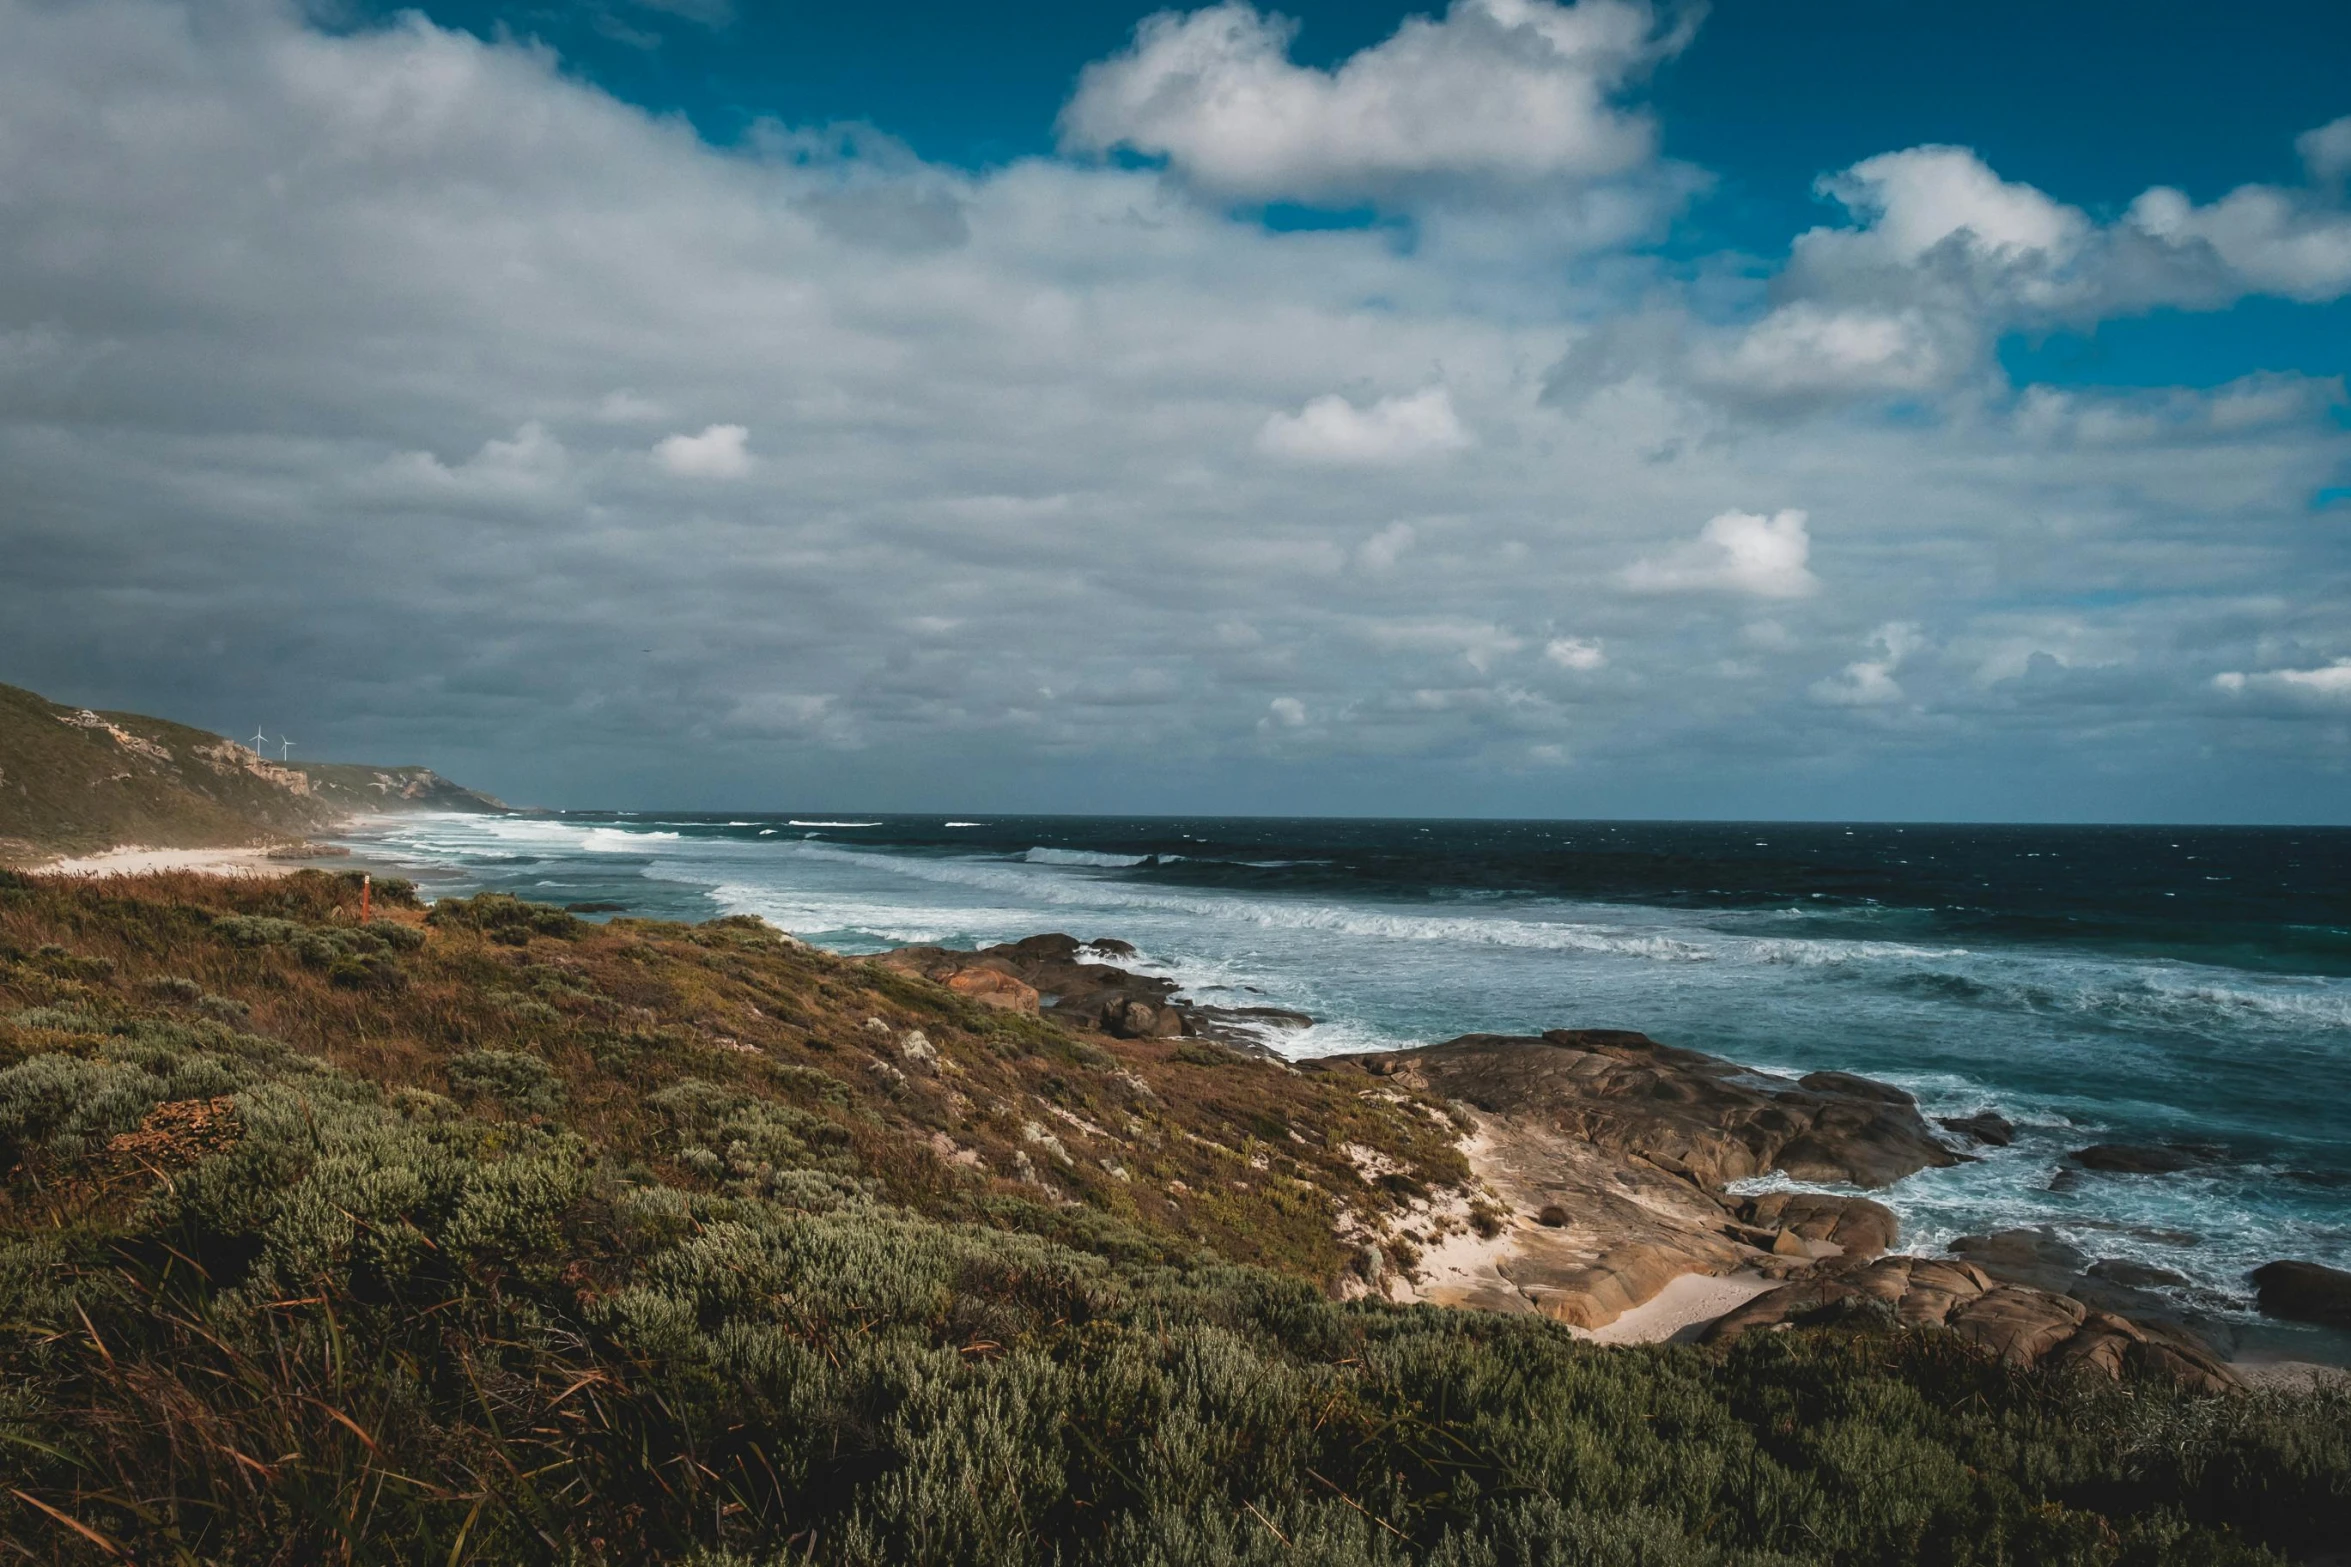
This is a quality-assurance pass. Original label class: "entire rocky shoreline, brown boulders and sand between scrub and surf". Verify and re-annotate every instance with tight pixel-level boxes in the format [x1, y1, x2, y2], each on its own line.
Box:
[877, 935, 2351, 1391]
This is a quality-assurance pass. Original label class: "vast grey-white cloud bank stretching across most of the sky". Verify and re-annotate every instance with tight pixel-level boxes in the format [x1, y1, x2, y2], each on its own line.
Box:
[0, 0, 2351, 813]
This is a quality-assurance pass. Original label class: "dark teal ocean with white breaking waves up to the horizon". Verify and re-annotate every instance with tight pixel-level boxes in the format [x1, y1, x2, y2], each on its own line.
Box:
[343, 811, 2351, 1358]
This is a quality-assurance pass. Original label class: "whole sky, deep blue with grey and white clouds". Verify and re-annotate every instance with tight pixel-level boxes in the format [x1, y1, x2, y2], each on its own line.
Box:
[0, 0, 2351, 822]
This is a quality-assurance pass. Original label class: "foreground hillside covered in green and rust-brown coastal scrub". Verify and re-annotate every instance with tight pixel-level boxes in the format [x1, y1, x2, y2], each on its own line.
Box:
[0, 872, 2351, 1567]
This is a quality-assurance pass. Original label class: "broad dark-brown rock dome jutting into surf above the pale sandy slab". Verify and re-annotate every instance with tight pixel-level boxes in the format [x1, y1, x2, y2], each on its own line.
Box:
[1333, 1029, 1961, 1191]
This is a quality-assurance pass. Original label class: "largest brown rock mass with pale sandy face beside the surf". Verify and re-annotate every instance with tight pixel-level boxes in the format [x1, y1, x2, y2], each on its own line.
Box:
[1319, 1029, 2236, 1391]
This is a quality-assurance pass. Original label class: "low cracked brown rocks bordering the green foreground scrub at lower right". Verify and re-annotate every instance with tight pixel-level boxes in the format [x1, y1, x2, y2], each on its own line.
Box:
[1704, 1257, 2238, 1393]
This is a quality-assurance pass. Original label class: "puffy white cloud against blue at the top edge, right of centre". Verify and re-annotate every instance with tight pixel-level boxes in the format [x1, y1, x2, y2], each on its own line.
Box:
[1060, 0, 1688, 202]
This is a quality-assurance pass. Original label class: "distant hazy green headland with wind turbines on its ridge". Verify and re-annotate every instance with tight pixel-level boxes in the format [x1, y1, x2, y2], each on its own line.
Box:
[0, 686, 498, 860]
